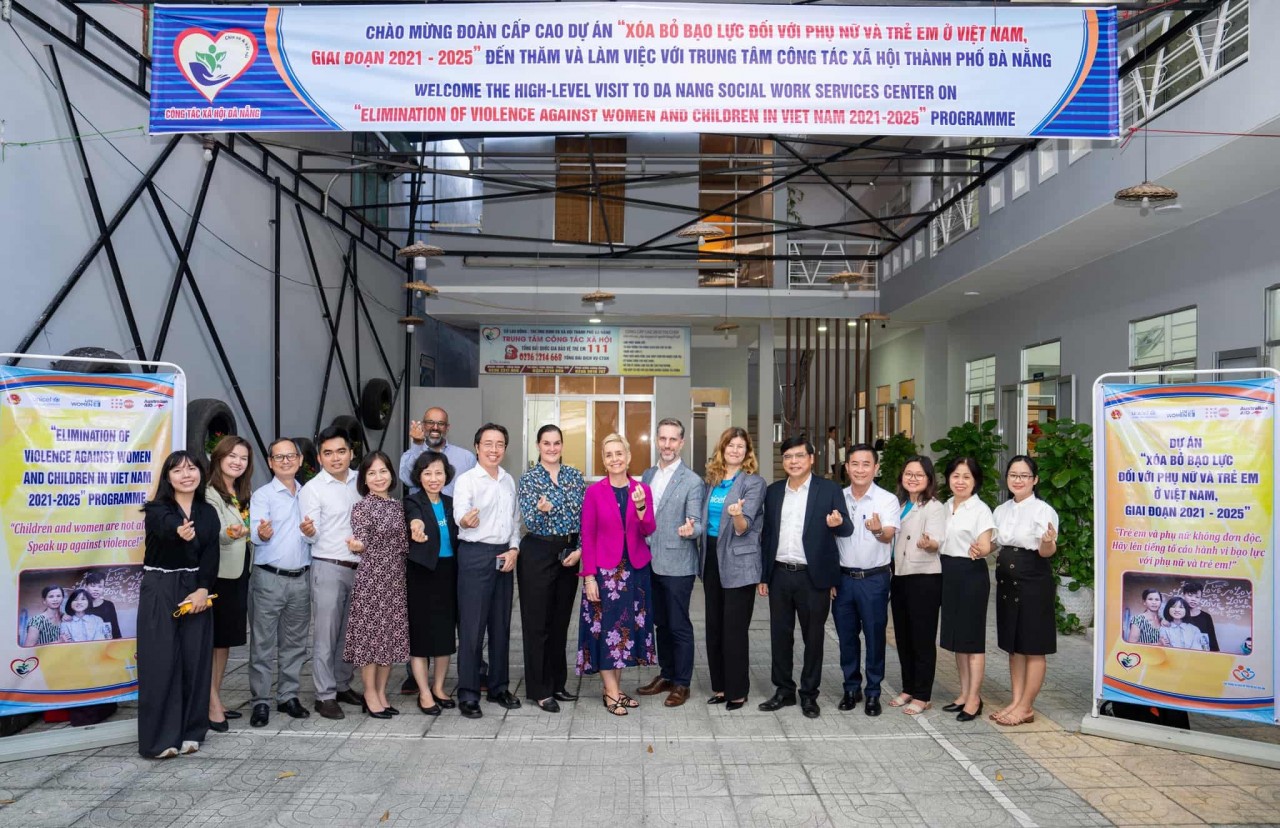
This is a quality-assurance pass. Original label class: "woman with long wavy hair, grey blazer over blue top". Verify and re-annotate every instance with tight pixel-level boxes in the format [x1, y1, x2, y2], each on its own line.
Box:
[703, 426, 765, 710]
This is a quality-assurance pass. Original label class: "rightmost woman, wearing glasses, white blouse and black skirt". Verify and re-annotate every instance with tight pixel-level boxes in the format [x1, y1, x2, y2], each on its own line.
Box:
[991, 454, 1059, 726]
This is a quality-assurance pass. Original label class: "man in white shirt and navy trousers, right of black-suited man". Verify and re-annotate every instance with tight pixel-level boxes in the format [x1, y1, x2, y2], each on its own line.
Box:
[831, 443, 901, 715]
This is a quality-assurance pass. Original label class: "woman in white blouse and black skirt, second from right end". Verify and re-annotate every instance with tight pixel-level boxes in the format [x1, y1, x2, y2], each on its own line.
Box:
[938, 457, 996, 722]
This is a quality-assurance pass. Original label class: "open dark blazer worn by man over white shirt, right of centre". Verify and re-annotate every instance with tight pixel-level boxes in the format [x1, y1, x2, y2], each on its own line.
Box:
[760, 475, 854, 589]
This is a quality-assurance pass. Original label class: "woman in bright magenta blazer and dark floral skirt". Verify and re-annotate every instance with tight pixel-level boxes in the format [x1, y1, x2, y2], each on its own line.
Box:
[577, 434, 658, 715]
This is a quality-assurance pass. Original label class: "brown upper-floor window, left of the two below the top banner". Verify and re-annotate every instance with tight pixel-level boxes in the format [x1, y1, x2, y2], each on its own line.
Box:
[556, 138, 627, 244]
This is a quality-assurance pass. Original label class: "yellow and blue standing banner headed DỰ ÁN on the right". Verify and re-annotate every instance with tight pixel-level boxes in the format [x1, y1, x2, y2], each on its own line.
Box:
[1094, 379, 1276, 723]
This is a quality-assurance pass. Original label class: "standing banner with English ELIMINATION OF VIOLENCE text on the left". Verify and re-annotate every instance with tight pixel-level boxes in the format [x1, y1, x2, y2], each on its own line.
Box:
[0, 367, 186, 715]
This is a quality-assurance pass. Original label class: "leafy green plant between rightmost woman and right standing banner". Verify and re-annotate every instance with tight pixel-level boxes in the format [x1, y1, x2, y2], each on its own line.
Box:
[1036, 420, 1093, 632]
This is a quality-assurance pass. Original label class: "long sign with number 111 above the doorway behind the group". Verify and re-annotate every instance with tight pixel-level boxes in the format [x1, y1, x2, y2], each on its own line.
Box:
[480, 325, 689, 376]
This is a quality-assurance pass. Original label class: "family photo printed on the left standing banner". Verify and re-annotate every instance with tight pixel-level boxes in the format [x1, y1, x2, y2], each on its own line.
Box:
[17, 564, 142, 649]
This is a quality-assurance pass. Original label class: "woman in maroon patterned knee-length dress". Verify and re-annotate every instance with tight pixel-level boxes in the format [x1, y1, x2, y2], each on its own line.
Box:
[342, 452, 408, 719]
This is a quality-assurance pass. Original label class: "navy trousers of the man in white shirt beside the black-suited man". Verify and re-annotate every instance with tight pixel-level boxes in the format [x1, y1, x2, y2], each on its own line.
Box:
[831, 572, 890, 697]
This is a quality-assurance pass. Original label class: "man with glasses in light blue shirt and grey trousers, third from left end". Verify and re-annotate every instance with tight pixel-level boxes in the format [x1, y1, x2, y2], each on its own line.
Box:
[248, 438, 311, 727]
